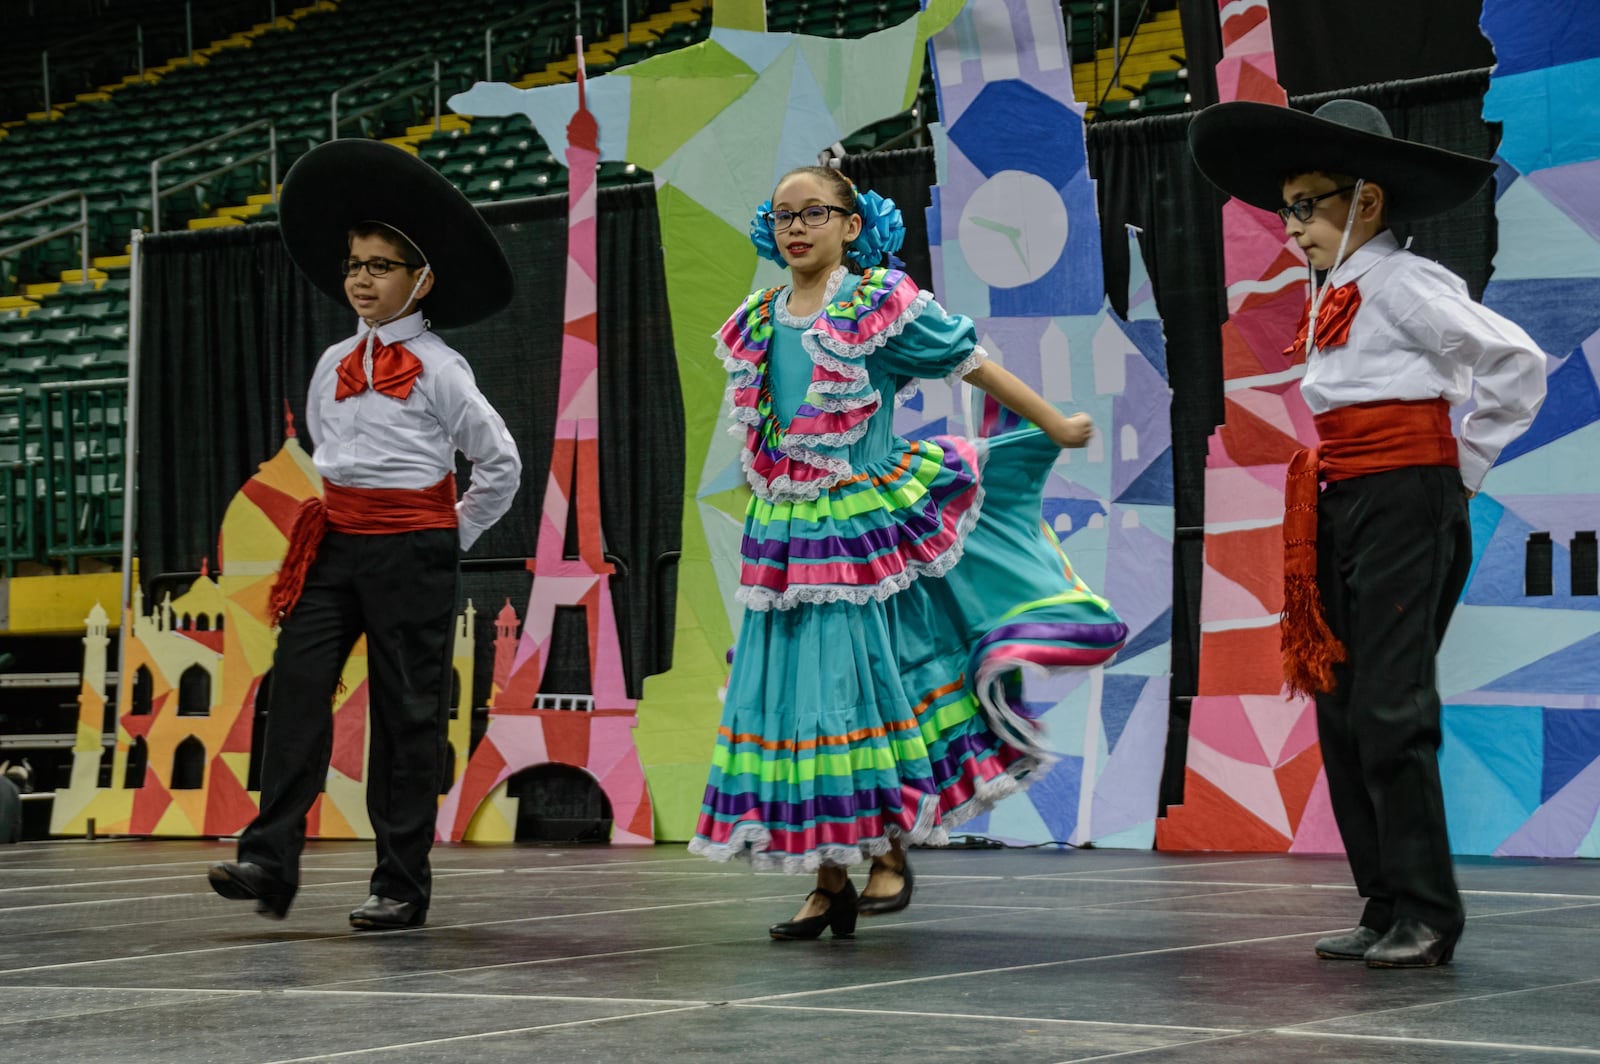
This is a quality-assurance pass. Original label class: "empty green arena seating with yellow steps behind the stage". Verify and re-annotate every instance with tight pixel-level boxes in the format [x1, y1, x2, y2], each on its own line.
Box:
[0, 0, 1187, 576]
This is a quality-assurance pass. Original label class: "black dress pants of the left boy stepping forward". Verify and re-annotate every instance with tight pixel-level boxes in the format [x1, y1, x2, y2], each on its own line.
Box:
[238, 528, 459, 907]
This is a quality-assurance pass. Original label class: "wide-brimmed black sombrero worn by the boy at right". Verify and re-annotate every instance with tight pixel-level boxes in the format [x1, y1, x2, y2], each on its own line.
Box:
[1189, 99, 1494, 222]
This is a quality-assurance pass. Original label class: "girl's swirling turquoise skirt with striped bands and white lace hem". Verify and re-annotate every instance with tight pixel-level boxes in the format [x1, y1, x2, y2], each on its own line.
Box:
[690, 430, 1128, 872]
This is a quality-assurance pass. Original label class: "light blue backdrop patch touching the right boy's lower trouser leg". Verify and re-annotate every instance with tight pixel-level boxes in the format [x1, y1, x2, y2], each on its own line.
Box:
[1438, 706, 1544, 854]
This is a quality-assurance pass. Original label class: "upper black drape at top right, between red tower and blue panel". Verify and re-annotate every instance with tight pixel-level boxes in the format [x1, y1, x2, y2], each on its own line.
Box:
[1260, 0, 1497, 96]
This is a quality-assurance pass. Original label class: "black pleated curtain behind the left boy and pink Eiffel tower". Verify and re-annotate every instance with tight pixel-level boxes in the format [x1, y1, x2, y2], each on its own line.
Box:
[138, 186, 683, 706]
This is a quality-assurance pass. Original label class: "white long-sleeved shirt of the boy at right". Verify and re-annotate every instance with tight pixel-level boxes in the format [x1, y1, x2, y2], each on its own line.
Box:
[1301, 230, 1544, 491]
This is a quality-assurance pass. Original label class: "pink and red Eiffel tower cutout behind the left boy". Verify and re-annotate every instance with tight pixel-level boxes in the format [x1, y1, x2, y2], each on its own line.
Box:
[438, 49, 654, 845]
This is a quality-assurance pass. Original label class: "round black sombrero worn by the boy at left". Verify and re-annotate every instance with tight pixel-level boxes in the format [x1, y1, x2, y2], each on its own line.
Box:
[278, 139, 512, 328]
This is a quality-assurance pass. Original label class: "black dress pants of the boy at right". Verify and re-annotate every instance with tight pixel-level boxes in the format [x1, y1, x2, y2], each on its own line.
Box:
[1317, 466, 1472, 933]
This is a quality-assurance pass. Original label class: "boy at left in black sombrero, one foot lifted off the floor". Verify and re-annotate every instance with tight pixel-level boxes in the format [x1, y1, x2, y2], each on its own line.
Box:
[210, 141, 522, 930]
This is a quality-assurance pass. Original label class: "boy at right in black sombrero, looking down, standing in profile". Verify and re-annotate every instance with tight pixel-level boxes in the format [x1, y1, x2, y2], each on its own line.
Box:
[1189, 99, 1546, 968]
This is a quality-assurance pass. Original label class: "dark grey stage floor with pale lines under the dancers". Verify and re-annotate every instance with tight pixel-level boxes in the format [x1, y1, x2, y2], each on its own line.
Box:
[0, 840, 1600, 1064]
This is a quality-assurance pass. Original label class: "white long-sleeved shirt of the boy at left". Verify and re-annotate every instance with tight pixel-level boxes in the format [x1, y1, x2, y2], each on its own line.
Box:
[306, 312, 522, 550]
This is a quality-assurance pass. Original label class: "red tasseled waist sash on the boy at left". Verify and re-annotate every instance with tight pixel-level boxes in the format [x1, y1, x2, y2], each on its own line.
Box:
[267, 474, 456, 624]
